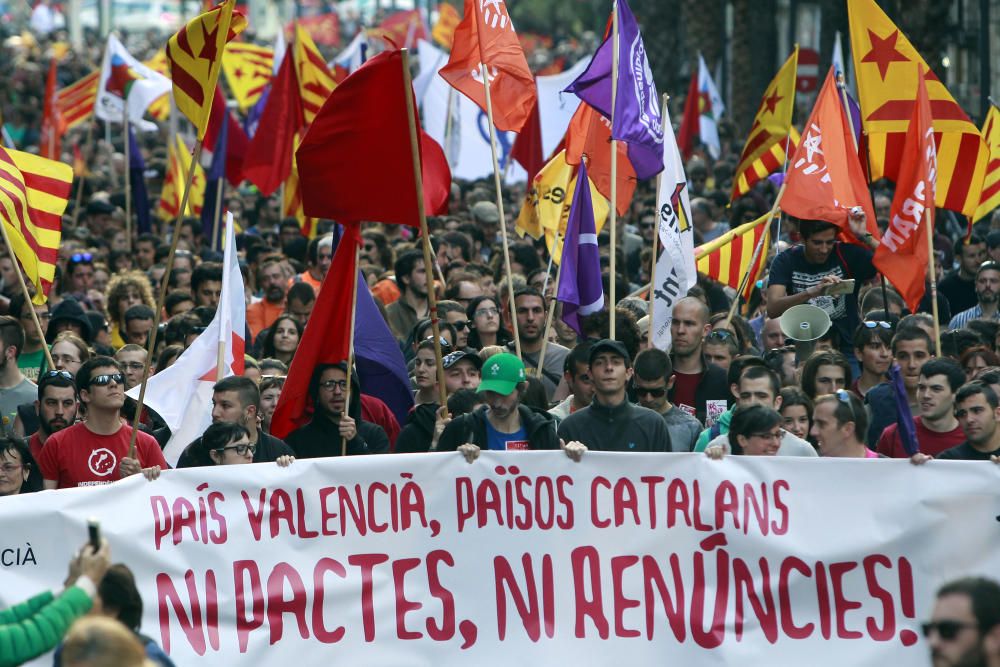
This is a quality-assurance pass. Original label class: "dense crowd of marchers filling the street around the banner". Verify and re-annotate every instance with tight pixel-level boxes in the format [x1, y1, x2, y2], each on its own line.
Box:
[0, 13, 1000, 665]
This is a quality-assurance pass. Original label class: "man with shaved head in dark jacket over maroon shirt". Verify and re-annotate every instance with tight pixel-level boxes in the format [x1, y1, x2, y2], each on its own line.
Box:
[670, 296, 729, 428]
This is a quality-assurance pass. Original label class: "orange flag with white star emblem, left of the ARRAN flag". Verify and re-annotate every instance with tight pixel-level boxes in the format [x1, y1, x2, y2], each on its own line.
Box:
[781, 67, 878, 238]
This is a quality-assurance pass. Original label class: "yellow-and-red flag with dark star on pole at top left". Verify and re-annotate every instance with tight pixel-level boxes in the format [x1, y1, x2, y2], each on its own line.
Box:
[167, 0, 247, 141]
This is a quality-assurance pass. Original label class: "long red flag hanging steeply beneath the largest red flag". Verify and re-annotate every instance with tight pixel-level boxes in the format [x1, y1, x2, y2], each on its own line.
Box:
[271, 224, 362, 439]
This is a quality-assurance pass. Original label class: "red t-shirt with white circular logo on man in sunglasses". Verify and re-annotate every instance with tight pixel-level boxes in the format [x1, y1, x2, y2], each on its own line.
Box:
[38, 422, 170, 489]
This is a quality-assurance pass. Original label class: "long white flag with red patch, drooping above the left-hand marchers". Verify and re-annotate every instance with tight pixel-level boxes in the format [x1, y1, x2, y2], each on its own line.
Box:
[128, 213, 246, 465]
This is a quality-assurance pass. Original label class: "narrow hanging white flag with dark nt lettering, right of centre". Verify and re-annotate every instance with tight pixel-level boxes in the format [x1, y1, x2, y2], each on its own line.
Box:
[649, 107, 705, 352]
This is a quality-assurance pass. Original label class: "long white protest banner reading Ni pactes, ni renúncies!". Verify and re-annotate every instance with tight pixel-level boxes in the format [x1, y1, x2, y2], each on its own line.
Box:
[0, 452, 1000, 667]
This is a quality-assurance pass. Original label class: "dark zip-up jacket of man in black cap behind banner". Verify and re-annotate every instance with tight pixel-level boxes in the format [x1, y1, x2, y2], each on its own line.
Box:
[559, 396, 668, 452]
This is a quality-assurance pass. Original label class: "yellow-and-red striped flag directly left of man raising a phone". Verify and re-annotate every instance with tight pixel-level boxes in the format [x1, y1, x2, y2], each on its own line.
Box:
[694, 212, 771, 298]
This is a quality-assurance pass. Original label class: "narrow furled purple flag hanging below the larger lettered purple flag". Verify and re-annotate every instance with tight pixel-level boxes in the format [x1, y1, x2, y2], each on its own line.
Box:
[556, 160, 604, 336]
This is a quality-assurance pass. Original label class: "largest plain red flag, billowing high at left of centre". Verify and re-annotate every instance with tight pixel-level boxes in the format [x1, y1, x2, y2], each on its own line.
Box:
[292, 50, 451, 227]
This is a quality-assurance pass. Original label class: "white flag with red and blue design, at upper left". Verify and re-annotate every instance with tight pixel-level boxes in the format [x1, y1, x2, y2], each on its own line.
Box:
[94, 35, 172, 132]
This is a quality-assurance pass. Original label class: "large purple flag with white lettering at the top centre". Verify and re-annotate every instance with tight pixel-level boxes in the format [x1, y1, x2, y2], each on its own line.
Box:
[566, 0, 663, 178]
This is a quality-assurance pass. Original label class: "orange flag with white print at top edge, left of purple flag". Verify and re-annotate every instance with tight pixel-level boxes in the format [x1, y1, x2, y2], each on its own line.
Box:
[439, 0, 538, 132]
